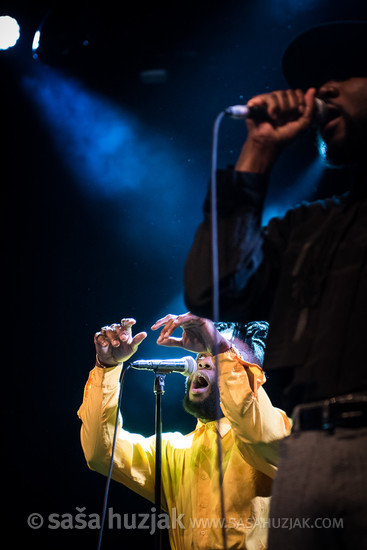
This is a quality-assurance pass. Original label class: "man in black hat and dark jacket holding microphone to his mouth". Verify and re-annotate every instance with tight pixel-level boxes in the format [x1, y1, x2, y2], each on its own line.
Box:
[185, 21, 367, 550]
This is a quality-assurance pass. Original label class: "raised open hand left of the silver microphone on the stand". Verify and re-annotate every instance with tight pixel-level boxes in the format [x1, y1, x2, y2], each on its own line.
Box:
[94, 318, 147, 367]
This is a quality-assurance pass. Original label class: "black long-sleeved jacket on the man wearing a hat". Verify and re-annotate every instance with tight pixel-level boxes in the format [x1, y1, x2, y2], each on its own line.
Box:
[185, 170, 367, 413]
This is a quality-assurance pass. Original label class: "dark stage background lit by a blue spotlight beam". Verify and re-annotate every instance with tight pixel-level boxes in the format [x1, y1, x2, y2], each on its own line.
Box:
[0, 0, 367, 550]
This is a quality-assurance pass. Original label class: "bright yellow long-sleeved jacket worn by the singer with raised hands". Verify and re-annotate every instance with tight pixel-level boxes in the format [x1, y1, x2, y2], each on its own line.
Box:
[78, 348, 290, 550]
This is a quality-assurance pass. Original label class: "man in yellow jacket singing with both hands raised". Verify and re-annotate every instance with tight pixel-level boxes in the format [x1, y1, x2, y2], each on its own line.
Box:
[78, 313, 290, 550]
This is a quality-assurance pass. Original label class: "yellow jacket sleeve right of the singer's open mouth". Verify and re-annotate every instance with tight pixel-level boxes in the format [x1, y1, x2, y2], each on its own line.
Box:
[218, 348, 291, 478]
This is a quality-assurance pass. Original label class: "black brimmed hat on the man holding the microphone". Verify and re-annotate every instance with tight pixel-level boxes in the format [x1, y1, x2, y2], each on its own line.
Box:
[282, 21, 367, 90]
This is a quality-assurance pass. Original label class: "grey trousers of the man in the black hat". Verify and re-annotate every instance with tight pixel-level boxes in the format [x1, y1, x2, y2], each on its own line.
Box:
[268, 427, 367, 550]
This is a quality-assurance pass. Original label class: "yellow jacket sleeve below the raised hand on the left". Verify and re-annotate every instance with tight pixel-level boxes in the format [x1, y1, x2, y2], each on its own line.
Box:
[78, 367, 155, 502]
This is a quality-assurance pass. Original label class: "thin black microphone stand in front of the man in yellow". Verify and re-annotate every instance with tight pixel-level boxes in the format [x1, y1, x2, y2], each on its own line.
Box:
[154, 371, 166, 550]
